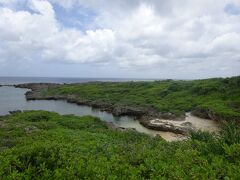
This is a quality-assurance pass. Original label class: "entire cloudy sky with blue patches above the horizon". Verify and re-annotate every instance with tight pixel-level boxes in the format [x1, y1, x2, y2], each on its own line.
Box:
[0, 0, 240, 79]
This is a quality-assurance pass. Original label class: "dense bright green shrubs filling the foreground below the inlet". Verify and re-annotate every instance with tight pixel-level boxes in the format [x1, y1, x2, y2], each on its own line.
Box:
[0, 111, 240, 180]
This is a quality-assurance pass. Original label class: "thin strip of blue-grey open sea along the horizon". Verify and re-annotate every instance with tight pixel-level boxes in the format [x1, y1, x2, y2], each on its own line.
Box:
[0, 77, 156, 85]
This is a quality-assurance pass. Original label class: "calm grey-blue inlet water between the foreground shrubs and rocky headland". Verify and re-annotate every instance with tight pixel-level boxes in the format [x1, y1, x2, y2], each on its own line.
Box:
[0, 86, 167, 137]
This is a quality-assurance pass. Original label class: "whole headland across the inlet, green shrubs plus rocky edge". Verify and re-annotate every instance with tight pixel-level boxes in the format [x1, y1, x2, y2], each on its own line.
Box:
[15, 76, 240, 134]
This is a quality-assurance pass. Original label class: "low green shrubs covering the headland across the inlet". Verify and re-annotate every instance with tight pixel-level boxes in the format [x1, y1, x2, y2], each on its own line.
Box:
[43, 76, 240, 120]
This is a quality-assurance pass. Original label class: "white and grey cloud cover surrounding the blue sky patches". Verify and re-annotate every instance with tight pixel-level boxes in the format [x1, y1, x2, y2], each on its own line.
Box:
[0, 0, 240, 78]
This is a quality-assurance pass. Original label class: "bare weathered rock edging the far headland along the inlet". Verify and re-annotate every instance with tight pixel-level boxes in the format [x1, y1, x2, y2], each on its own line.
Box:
[14, 83, 215, 135]
